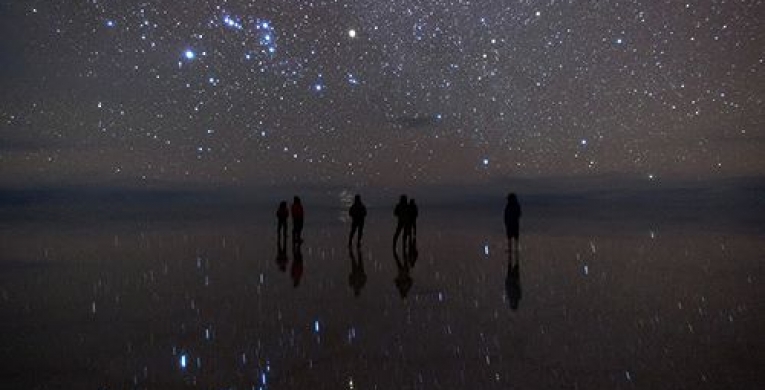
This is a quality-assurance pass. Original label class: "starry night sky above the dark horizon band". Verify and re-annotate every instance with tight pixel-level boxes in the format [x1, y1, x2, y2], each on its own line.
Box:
[0, 0, 765, 186]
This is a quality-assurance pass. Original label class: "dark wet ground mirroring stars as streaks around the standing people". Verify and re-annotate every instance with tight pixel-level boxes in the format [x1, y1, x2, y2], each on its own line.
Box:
[0, 209, 765, 389]
